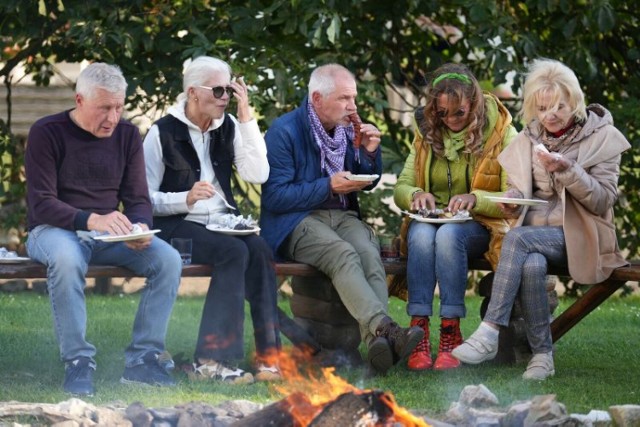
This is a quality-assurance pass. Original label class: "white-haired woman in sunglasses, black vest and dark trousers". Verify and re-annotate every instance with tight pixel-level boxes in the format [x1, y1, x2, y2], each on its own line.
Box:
[144, 56, 280, 384]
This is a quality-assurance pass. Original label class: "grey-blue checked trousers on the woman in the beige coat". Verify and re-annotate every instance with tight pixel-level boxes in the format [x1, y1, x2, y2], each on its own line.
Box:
[483, 226, 567, 354]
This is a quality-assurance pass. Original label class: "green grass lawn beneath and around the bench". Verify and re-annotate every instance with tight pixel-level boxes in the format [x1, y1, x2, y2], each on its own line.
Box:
[0, 292, 640, 416]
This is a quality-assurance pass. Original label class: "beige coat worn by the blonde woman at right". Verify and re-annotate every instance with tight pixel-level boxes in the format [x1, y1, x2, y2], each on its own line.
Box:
[498, 105, 631, 284]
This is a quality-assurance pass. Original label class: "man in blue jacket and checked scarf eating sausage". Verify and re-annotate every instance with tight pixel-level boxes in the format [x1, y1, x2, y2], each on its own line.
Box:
[261, 64, 424, 373]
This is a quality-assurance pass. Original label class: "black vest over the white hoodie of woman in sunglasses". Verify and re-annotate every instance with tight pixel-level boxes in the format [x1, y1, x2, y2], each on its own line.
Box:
[153, 114, 238, 240]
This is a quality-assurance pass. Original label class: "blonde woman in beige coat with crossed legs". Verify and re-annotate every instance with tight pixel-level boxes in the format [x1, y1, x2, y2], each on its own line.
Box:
[452, 59, 630, 380]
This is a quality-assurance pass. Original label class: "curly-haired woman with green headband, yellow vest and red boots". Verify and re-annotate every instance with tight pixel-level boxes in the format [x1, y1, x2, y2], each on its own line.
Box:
[394, 64, 516, 370]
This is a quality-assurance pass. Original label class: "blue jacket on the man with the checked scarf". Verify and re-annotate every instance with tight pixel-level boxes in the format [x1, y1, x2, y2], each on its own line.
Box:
[260, 97, 382, 258]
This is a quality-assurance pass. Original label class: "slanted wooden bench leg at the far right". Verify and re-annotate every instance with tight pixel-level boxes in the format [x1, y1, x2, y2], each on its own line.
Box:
[551, 280, 626, 343]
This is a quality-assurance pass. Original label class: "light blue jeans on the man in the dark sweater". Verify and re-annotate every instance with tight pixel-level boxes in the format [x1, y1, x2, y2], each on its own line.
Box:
[27, 225, 182, 367]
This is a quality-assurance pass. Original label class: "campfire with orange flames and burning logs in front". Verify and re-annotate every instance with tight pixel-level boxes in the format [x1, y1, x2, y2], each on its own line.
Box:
[233, 353, 427, 427]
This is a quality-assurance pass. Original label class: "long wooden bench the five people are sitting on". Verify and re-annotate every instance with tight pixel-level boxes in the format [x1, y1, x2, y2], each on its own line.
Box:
[0, 260, 640, 352]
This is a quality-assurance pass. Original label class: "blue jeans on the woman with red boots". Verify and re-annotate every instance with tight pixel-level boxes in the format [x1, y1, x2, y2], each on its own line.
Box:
[407, 221, 489, 319]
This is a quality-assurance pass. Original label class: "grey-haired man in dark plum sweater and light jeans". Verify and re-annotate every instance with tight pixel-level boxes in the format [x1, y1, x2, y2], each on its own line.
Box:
[25, 63, 181, 396]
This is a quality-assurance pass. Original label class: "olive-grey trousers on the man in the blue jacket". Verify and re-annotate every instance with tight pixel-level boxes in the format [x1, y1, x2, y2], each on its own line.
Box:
[285, 209, 389, 345]
